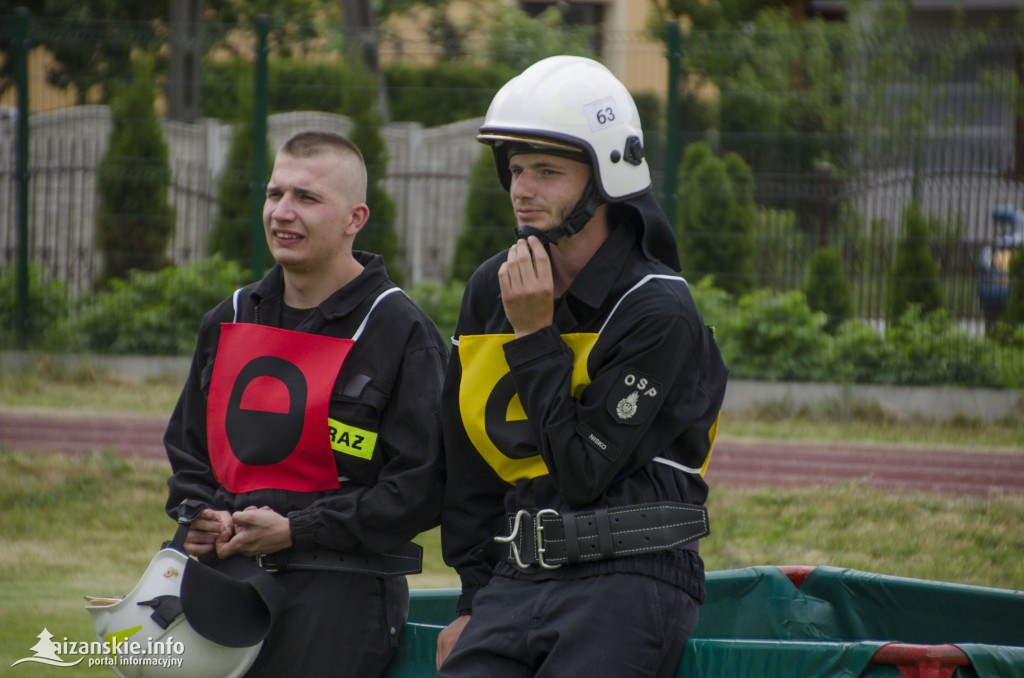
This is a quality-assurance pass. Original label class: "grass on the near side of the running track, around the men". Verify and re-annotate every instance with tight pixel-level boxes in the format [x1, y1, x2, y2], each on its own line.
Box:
[0, 451, 1024, 678]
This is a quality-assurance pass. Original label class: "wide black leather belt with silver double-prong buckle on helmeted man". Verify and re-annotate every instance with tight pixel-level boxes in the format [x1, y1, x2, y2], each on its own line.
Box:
[495, 502, 711, 569]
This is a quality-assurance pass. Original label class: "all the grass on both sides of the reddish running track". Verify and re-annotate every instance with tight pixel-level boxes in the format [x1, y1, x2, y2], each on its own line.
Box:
[0, 361, 1024, 678]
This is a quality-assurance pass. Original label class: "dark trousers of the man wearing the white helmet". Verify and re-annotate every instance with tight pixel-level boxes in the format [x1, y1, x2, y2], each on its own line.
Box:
[437, 575, 699, 678]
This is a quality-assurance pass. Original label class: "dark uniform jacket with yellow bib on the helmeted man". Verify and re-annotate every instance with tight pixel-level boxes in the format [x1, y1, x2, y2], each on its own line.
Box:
[441, 219, 727, 613]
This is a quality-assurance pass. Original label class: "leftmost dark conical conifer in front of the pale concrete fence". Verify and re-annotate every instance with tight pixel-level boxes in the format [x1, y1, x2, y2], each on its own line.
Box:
[95, 58, 175, 285]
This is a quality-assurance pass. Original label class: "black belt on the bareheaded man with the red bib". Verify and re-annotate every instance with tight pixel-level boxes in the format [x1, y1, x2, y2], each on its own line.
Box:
[256, 542, 423, 577]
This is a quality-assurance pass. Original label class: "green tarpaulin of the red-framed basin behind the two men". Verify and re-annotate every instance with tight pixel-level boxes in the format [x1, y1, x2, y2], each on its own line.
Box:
[386, 565, 1024, 678]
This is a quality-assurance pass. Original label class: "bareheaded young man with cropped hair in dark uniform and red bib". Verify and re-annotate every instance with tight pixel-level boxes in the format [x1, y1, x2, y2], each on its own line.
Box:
[164, 132, 447, 678]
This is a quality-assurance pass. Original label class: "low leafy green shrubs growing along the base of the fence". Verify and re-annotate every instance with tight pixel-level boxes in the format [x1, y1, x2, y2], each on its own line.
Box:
[0, 257, 1024, 389]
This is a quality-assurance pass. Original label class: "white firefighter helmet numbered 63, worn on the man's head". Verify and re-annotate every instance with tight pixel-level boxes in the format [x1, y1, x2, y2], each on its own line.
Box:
[476, 55, 650, 203]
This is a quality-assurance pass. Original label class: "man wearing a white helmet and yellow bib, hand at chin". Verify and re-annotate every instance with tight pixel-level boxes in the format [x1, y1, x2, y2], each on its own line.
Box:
[437, 56, 727, 678]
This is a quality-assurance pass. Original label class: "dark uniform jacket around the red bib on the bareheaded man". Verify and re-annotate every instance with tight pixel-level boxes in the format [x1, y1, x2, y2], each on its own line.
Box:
[164, 252, 447, 553]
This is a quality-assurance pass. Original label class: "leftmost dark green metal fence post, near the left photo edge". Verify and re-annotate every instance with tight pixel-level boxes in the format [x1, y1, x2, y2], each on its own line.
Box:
[14, 7, 30, 350]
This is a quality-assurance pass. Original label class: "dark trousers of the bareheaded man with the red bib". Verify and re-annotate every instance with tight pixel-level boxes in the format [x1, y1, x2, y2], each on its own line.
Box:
[246, 571, 409, 678]
